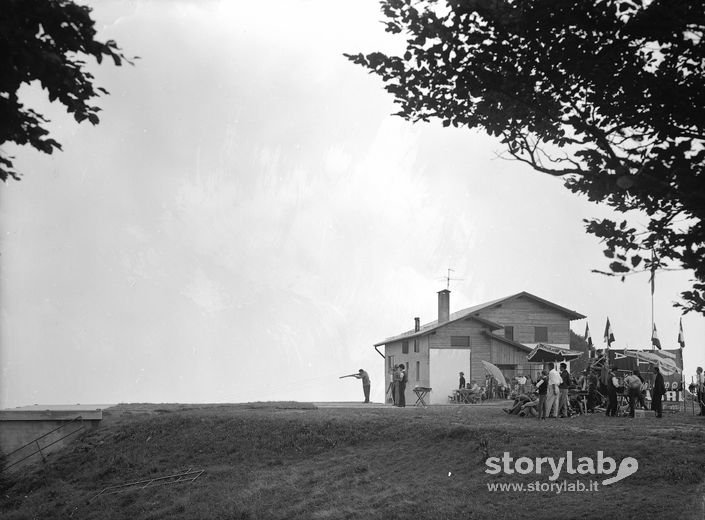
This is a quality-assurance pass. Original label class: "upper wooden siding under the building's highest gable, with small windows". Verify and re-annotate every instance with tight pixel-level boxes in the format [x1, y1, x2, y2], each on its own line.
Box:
[472, 296, 570, 348]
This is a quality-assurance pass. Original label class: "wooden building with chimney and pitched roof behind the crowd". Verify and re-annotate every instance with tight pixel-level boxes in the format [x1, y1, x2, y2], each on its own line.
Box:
[375, 289, 585, 404]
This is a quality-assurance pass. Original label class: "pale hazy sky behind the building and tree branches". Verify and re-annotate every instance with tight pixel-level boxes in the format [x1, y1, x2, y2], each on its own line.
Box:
[0, 0, 705, 408]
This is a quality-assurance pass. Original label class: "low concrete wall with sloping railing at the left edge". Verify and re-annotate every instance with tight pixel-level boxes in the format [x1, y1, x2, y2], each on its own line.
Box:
[0, 408, 103, 469]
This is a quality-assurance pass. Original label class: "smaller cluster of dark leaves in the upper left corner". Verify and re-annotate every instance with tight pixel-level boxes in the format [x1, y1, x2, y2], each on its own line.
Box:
[0, 0, 128, 181]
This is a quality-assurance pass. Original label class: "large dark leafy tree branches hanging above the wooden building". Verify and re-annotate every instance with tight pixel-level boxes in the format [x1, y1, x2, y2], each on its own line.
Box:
[346, 0, 705, 314]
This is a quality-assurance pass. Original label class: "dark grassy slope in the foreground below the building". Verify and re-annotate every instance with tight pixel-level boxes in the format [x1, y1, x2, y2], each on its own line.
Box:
[0, 403, 705, 520]
